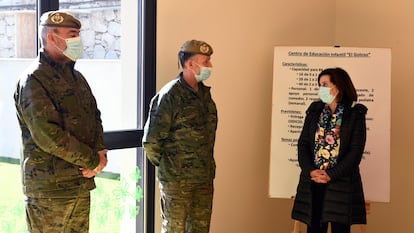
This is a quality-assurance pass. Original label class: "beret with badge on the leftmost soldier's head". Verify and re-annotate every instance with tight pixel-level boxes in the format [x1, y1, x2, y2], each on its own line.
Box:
[40, 11, 81, 29]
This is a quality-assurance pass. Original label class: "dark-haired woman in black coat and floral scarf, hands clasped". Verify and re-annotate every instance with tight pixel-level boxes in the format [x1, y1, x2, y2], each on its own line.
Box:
[292, 68, 367, 233]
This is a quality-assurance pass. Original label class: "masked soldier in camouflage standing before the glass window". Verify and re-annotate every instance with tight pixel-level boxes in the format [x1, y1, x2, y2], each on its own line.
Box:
[14, 11, 107, 233]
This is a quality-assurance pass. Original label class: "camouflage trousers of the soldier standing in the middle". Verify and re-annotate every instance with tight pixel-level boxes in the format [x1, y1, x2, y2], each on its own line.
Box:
[160, 183, 214, 233]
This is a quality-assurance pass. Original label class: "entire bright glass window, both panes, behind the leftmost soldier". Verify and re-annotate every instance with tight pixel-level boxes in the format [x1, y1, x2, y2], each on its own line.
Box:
[0, 0, 145, 233]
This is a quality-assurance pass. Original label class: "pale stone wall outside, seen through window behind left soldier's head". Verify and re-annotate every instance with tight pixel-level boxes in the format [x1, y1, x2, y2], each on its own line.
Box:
[0, 6, 121, 59]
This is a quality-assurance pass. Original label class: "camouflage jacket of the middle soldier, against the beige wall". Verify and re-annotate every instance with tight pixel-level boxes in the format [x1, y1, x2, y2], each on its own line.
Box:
[143, 74, 217, 183]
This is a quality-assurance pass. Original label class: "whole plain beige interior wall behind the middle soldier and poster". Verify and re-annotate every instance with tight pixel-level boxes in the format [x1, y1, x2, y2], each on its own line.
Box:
[157, 0, 414, 233]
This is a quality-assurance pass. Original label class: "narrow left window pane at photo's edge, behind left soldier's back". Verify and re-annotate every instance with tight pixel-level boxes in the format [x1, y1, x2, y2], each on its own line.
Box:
[0, 0, 36, 233]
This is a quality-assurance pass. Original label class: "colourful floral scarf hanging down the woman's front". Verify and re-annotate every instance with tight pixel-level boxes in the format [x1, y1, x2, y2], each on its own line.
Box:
[314, 104, 344, 170]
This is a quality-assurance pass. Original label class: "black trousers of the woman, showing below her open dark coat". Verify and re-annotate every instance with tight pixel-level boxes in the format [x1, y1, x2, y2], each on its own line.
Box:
[307, 183, 351, 233]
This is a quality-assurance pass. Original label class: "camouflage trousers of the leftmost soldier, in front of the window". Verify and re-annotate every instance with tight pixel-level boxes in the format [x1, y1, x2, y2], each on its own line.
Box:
[26, 195, 90, 233]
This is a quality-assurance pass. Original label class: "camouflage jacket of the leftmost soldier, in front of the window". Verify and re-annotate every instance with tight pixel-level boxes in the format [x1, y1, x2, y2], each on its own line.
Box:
[14, 52, 105, 197]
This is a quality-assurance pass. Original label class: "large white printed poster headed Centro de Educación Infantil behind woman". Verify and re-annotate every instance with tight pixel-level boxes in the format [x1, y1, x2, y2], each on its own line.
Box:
[269, 47, 391, 202]
